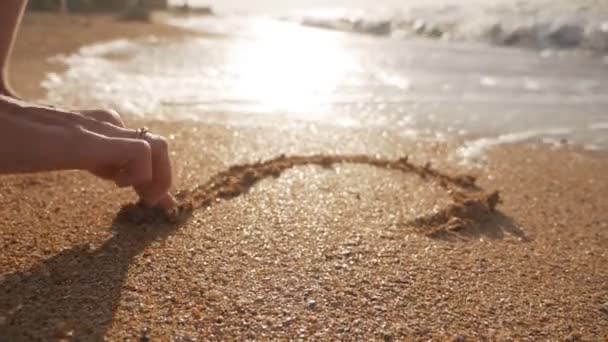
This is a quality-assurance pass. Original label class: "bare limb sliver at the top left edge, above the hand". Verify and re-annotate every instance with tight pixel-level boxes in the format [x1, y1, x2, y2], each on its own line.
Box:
[0, 0, 27, 96]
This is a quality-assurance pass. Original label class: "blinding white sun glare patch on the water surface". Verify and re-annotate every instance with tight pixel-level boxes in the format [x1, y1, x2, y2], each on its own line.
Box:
[227, 21, 356, 119]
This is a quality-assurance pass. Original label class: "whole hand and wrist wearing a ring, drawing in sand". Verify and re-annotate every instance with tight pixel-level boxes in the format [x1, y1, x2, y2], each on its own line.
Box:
[0, 95, 176, 210]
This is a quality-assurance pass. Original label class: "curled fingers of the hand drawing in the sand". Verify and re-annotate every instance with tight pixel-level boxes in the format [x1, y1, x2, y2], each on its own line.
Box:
[79, 110, 176, 210]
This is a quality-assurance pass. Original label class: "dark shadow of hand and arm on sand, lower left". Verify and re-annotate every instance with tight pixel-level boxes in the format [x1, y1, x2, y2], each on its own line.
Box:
[0, 211, 190, 341]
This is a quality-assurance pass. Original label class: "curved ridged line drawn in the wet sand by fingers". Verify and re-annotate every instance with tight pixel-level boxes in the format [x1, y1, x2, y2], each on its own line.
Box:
[117, 154, 500, 236]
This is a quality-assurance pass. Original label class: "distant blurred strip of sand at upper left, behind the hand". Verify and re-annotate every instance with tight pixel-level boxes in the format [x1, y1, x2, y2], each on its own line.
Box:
[9, 12, 198, 99]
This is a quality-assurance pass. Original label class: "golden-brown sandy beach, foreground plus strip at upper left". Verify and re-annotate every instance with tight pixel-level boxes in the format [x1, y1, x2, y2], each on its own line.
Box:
[0, 10, 608, 341]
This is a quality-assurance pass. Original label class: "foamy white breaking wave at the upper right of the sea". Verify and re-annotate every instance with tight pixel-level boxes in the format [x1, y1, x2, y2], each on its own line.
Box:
[286, 7, 608, 53]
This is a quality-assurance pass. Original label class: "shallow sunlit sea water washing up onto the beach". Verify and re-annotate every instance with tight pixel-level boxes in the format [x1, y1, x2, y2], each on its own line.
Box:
[43, 0, 608, 162]
